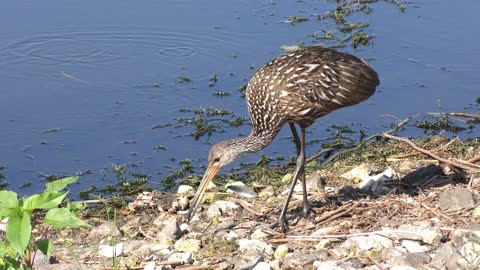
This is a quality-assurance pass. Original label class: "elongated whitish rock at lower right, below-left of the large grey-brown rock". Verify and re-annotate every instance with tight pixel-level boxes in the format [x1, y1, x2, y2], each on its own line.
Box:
[394, 224, 443, 246]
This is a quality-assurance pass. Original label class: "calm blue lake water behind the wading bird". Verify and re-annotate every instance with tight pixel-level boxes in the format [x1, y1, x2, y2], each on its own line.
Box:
[0, 0, 480, 193]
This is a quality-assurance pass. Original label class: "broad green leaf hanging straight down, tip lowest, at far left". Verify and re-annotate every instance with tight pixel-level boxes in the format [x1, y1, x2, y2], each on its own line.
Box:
[7, 208, 32, 256]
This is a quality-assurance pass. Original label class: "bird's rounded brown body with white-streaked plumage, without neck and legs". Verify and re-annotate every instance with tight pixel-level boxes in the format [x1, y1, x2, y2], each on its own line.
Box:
[247, 46, 379, 136]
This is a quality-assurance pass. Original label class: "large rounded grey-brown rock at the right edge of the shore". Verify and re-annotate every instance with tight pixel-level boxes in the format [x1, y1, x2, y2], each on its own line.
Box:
[438, 188, 476, 212]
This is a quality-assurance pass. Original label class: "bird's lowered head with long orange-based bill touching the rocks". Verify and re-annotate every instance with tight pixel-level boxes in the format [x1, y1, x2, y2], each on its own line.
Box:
[187, 139, 248, 221]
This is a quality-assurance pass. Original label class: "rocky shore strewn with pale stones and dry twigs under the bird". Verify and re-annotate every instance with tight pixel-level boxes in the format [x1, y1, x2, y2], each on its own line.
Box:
[36, 137, 480, 270]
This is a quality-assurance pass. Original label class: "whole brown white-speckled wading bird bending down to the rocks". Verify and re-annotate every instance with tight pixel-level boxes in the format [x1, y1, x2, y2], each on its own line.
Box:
[187, 46, 379, 232]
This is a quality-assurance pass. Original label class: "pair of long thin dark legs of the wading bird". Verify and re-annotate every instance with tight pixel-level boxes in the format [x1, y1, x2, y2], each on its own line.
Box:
[278, 124, 310, 233]
